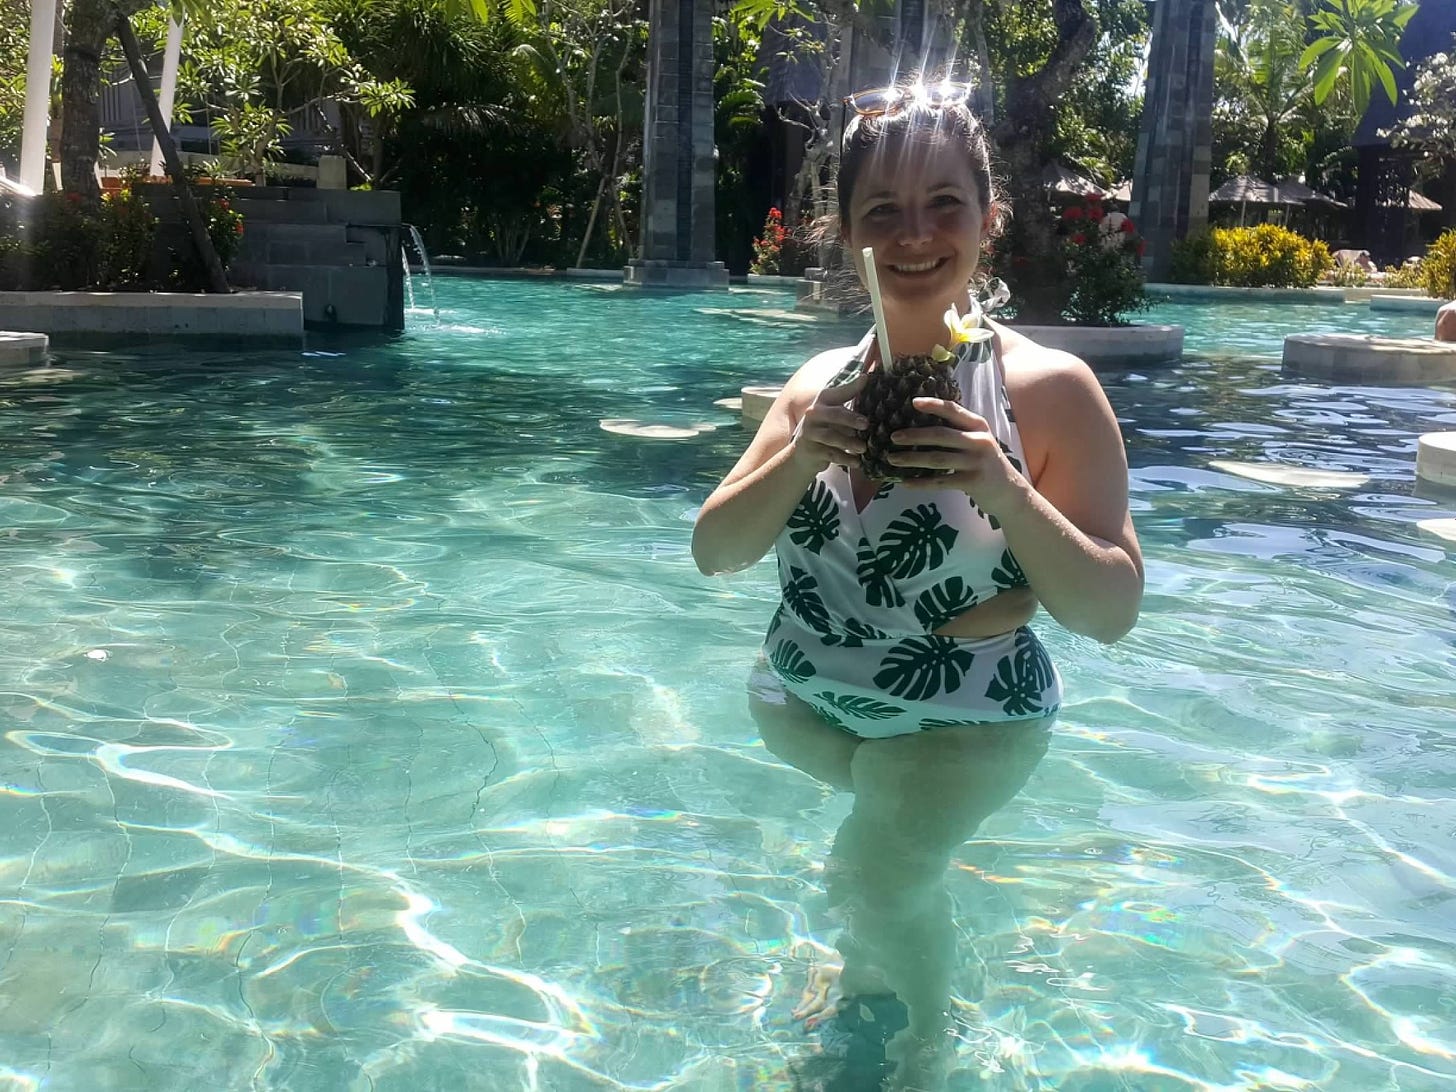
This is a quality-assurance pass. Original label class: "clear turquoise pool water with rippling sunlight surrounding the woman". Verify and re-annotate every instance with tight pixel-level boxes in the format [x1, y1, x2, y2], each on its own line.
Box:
[0, 281, 1456, 1092]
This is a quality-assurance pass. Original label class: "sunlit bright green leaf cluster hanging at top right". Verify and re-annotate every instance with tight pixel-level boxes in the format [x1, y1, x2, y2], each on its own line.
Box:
[1299, 0, 1417, 116]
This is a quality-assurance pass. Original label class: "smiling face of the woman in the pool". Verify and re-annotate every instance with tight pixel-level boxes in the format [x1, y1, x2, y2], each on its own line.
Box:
[844, 135, 984, 309]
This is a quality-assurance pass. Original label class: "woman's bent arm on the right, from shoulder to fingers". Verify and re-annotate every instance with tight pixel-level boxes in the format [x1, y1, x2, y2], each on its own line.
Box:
[894, 347, 1143, 644]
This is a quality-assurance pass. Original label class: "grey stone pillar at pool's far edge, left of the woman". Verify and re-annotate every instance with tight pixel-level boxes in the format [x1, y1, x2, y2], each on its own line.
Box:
[623, 0, 728, 288]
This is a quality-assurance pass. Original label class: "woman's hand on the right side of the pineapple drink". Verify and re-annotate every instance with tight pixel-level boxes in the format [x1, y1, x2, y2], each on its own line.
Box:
[888, 397, 1026, 515]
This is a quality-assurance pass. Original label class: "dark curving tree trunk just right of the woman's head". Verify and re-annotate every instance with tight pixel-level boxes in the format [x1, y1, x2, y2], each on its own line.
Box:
[992, 0, 1098, 322]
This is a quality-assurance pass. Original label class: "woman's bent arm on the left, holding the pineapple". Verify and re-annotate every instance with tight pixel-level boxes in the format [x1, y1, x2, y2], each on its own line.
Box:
[693, 349, 863, 575]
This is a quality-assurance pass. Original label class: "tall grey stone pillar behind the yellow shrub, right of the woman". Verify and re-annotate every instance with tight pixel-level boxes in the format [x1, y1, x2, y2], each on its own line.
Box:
[1130, 0, 1216, 281]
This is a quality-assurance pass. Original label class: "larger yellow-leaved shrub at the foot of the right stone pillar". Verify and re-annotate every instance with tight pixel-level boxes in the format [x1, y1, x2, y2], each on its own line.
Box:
[1172, 224, 1335, 288]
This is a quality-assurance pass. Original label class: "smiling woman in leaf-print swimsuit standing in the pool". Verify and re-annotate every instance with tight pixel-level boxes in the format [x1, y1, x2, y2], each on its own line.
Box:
[693, 84, 1143, 1089]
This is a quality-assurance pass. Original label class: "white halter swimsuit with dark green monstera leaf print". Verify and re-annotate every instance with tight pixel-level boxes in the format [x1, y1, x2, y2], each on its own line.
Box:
[754, 331, 1061, 740]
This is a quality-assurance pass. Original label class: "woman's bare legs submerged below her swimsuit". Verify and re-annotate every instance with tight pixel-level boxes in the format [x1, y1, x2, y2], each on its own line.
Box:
[751, 681, 1051, 1088]
